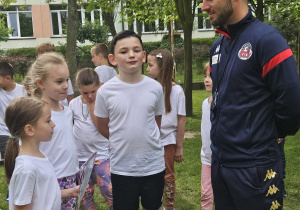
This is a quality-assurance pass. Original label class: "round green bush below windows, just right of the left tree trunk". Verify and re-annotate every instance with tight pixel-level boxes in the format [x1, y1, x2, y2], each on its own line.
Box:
[77, 20, 109, 44]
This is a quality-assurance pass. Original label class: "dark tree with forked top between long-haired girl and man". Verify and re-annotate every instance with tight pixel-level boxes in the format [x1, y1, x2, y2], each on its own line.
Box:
[175, 0, 197, 116]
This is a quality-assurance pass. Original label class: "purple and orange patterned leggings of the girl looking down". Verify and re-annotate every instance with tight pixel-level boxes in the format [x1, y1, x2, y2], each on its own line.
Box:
[79, 159, 113, 210]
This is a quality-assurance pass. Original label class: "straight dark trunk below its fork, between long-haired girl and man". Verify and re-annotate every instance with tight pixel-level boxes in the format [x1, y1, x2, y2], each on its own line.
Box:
[183, 22, 193, 117]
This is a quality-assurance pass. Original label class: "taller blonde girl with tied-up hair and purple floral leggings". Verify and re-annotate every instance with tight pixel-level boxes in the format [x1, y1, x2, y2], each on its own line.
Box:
[29, 52, 78, 209]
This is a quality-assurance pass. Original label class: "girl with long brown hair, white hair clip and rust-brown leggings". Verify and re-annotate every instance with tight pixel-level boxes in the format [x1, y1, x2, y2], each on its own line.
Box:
[147, 49, 186, 209]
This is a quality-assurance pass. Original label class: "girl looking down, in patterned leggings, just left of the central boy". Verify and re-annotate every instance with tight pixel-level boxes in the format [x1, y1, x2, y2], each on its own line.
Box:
[69, 68, 113, 210]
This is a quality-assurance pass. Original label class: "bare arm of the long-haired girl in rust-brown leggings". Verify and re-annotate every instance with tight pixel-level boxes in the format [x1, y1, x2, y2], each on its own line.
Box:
[175, 115, 185, 163]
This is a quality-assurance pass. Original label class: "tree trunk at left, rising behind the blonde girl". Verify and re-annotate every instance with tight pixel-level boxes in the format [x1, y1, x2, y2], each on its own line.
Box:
[66, 0, 79, 80]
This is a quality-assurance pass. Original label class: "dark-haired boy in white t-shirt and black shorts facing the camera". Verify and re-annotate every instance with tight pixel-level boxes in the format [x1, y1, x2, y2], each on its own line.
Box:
[95, 31, 165, 210]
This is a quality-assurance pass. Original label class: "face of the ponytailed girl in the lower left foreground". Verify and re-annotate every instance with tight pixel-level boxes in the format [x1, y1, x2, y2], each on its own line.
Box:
[32, 104, 55, 142]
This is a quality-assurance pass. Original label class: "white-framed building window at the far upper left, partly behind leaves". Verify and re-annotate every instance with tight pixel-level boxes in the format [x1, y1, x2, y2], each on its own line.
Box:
[0, 6, 33, 38]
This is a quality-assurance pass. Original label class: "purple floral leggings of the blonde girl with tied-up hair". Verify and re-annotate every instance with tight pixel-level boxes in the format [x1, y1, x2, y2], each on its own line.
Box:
[57, 175, 76, 210]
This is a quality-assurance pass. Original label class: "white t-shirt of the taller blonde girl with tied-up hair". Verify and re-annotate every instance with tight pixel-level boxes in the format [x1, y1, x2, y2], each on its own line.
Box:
[40, 106, 79, 179]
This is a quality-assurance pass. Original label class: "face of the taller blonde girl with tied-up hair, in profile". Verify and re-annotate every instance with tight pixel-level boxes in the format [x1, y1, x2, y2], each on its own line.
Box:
[41, 64, 69, 101]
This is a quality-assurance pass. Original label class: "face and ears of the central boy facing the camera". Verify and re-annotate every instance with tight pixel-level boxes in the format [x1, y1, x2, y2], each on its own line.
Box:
[108, 37, 146, 74]
